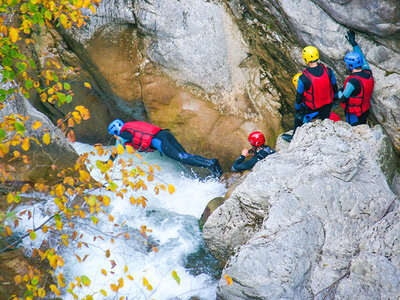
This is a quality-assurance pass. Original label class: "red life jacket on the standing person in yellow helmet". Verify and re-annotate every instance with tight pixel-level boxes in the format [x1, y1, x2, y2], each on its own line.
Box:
[303, 65, 333, 109]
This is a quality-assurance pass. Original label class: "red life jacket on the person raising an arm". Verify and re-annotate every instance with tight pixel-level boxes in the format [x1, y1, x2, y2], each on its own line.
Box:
[342, 70, 374, 117]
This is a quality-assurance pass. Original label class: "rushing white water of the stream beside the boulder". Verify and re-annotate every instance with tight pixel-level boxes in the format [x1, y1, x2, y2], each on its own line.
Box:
[17, 143, 226, 299]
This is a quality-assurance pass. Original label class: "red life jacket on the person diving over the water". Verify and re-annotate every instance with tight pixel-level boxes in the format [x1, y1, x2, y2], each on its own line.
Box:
[121, 121, 161, 152]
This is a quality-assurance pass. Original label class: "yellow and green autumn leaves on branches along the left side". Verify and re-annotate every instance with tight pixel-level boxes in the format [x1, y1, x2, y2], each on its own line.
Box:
[0, 0, 180, 299]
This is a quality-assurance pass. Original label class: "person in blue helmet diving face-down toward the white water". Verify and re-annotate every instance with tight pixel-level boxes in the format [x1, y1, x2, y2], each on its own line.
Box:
[108, 119, 223, 178]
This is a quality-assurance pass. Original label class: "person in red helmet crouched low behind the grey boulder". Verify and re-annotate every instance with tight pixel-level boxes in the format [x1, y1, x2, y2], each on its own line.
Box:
[232, 131, 275, 172]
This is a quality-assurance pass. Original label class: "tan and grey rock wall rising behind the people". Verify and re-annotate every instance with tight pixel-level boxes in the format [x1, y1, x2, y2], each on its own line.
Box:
[18, 0, 400, 162]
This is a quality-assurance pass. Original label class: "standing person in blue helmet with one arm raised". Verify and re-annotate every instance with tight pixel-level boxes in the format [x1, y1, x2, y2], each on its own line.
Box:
[339, 30, 374, 126]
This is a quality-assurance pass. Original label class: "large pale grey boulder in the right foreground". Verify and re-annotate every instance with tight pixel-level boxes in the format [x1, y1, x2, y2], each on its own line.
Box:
[203, 120, 400, 299]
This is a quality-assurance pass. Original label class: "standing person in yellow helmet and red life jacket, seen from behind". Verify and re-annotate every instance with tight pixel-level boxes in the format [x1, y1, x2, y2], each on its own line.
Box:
[282, 46, 338, 142]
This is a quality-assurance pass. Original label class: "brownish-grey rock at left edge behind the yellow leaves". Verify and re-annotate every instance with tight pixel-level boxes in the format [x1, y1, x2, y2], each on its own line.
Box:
[0, 89, 79, 188]
